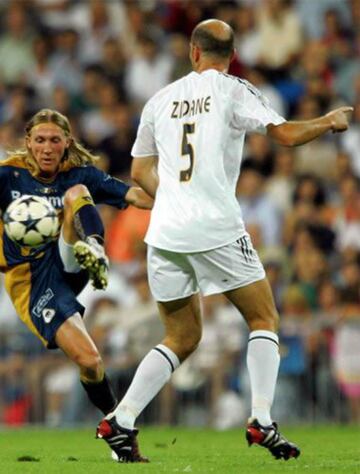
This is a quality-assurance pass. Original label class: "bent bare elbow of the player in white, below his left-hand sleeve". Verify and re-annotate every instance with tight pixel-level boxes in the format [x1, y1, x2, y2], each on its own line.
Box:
[131, 156, 159, 198]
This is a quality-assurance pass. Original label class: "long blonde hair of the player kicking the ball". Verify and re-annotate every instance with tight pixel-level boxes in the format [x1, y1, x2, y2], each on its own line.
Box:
[11, 109, 98, 176]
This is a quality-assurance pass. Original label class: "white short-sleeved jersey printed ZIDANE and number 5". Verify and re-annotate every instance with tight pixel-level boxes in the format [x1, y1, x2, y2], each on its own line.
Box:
[131, 69, 285, 253]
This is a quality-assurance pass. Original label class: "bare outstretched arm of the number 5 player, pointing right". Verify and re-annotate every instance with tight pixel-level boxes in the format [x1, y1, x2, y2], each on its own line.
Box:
[267, 107, 354, 146]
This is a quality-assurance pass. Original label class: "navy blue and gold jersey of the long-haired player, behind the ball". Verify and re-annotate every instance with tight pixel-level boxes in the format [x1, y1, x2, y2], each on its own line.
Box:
[0, 156, 129, 271]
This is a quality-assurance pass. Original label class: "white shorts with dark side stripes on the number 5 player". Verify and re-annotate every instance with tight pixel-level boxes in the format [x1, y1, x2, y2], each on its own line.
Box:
[147, 234, 265, 301]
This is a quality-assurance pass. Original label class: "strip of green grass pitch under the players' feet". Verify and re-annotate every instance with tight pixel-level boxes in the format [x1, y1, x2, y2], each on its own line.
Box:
[0, 426, 360, 474]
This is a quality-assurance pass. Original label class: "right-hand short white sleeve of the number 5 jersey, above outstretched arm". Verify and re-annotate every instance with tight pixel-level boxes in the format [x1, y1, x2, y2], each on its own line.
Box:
[232, 79, 286, 134]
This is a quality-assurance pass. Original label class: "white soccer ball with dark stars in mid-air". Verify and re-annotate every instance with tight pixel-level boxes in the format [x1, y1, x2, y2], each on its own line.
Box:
[3, 195, 59, 247]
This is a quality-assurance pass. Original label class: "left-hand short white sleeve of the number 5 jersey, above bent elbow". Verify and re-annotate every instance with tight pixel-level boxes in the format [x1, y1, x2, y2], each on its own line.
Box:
[131, 100, 158, 157]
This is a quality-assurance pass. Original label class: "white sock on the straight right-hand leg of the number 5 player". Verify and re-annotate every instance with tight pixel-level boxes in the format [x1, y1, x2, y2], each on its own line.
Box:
[247, 331, 280, 426]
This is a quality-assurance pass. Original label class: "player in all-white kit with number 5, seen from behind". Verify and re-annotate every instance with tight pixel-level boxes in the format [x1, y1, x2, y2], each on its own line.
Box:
[97, 20, 352, 462]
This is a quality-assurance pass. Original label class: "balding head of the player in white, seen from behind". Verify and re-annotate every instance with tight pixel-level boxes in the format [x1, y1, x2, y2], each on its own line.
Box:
[191, 19, 234, 59]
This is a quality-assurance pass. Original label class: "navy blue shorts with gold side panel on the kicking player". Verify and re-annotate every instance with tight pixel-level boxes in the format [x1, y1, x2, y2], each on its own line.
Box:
[5, 242, 88, 349]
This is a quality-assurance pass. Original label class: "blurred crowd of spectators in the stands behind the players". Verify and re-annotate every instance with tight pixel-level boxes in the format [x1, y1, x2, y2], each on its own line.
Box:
[0, 0, 360, 429]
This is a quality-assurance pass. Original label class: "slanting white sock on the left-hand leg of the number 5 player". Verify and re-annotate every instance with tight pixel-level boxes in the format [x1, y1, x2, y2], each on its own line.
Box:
[108, 344, 180, 429]
